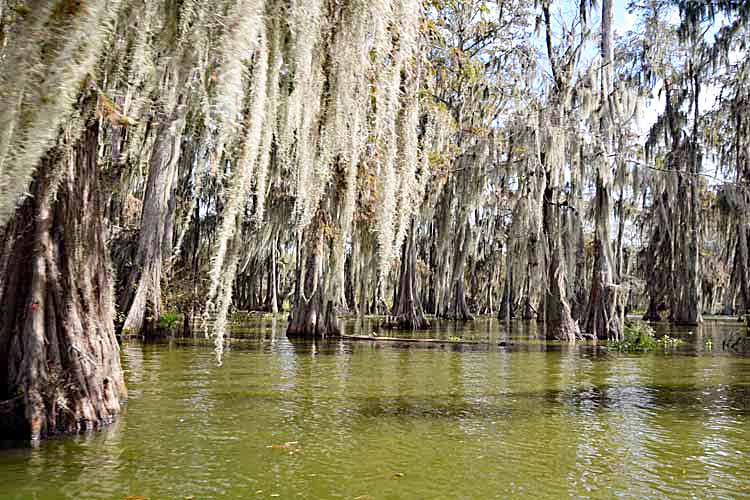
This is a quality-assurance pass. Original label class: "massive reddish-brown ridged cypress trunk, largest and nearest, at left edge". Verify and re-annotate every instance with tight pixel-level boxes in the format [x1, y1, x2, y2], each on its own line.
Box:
[0, 121, 126, 440]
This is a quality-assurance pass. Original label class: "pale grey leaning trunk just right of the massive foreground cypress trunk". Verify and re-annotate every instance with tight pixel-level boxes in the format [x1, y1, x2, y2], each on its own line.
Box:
[120, 112, 182, 337]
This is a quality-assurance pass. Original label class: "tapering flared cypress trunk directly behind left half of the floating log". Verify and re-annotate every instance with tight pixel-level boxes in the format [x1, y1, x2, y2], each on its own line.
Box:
[390, 219, 430, 330]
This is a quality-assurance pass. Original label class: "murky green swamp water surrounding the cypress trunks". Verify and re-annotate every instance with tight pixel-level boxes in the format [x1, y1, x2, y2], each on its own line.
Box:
[0, 320, 750, 500]
